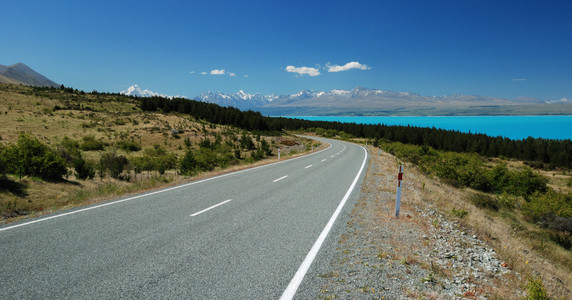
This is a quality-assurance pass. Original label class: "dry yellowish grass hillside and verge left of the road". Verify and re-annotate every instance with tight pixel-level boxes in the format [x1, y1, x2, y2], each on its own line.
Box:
[0, 85, 316, 223]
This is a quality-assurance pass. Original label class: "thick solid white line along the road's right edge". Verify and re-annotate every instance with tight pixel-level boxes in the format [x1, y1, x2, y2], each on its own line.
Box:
[280, 146, 368, 300]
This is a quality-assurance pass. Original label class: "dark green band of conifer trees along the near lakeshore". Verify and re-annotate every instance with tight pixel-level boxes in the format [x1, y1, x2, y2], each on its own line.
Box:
[139, 97, 572, 169]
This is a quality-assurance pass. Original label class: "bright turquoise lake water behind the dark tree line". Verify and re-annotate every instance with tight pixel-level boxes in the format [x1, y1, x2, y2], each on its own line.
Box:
[293, 116, 572, 139]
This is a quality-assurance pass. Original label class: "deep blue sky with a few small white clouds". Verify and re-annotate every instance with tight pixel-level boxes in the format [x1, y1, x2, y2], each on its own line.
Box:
[0, 0, 572, 100]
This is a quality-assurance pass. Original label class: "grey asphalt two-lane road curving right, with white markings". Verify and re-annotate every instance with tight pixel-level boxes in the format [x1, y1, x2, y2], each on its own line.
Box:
[0, 140, 367, 299]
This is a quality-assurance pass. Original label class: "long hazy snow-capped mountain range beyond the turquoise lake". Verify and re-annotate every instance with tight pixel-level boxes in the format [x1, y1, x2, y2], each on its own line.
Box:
[195, 87, 572, 116]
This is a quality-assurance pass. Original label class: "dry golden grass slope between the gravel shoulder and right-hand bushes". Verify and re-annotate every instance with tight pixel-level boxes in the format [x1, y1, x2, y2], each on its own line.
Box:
[374, 140, 572, 298]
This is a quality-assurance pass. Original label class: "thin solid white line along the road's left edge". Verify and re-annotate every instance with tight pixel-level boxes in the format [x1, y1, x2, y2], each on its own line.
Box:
[0, 144, 332, 232]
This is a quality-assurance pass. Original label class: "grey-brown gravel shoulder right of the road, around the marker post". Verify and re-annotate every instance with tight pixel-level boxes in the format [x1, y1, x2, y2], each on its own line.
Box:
[316, 151, 524, 299]
